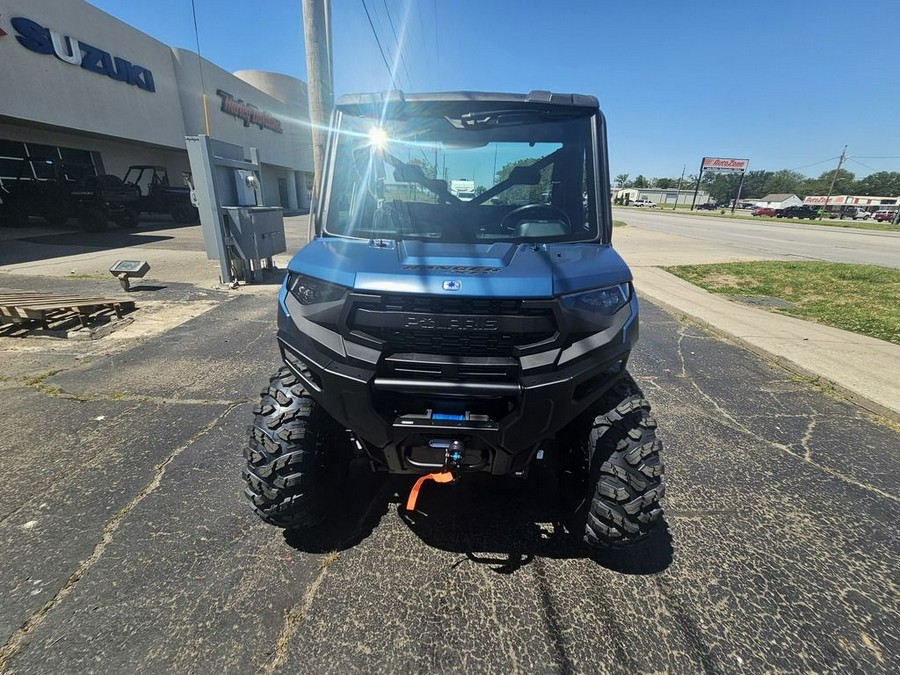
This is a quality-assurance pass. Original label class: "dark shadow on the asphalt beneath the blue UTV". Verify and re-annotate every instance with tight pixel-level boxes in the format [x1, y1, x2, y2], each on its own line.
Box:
[284, 461, 673, 575]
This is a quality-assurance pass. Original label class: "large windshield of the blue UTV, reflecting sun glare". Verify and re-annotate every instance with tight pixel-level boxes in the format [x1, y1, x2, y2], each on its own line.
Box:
[324, 109, 599, 243]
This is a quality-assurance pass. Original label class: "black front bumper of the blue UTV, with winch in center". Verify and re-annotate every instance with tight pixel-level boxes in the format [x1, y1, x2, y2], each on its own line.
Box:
[278, 294, 637, 474]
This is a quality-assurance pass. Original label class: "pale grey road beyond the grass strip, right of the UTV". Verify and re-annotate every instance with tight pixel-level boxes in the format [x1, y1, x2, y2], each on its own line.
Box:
[614, 208, 900, 268]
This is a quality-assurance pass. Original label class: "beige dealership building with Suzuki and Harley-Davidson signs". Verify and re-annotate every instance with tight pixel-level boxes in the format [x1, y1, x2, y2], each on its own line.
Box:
[0, 0, 313, 210]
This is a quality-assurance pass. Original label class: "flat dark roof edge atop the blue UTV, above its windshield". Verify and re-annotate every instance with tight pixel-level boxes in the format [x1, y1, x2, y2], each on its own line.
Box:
[335, 89, 599, 114]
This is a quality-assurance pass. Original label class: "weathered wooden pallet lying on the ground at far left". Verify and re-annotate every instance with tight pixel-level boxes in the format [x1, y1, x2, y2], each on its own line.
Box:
[0, 289, 134, 328]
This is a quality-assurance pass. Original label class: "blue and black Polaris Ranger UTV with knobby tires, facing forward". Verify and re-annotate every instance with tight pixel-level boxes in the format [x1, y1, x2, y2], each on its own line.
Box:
[244, 91, 663, 547]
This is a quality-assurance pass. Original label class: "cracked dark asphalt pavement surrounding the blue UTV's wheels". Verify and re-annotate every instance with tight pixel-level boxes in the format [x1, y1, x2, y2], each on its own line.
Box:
[0, 294, 900, 673]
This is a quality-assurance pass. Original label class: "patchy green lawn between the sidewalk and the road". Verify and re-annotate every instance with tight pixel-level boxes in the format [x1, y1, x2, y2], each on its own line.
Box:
[665, 261, 900, 344]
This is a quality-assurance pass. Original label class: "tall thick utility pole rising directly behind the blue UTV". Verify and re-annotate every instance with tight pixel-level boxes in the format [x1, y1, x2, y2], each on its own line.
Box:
[303, 0, 334, 223]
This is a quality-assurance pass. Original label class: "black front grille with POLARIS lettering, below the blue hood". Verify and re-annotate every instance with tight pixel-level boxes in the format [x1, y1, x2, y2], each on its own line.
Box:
[349, 295, 556, 356]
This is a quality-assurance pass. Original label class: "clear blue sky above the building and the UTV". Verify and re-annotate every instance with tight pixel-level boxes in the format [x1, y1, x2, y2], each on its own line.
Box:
[90, 0, 900, 177]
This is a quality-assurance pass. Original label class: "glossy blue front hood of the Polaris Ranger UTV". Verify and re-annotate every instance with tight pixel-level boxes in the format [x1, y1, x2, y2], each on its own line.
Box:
[288, 237, 631, 298]
